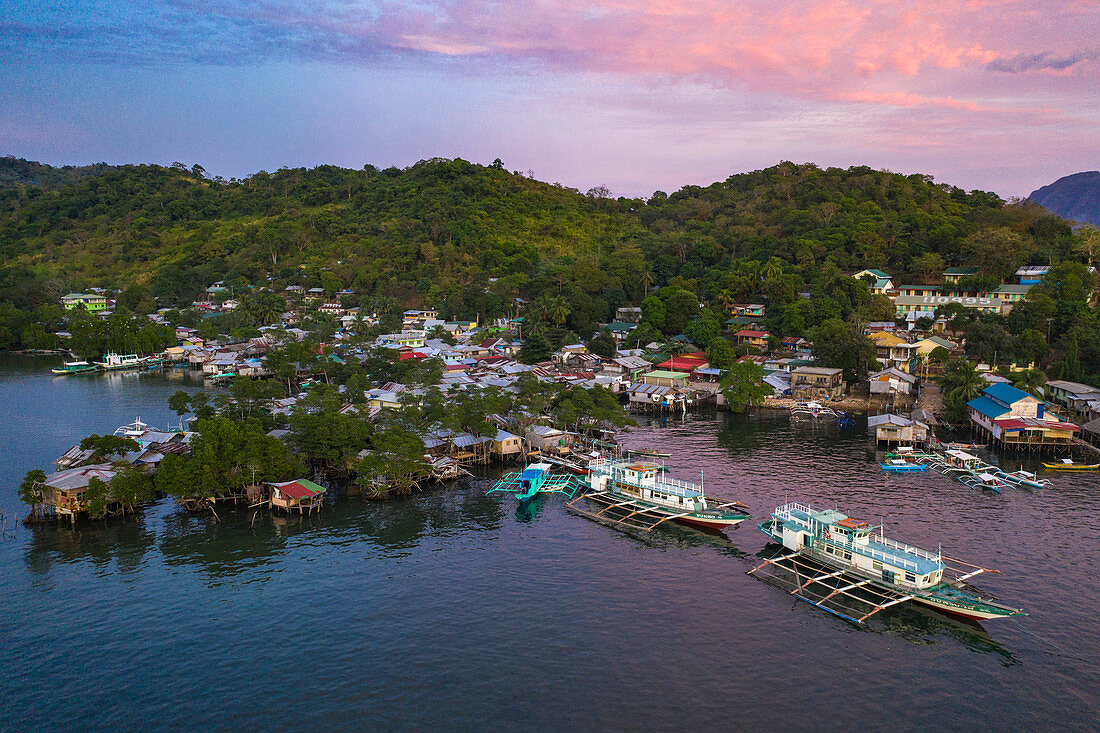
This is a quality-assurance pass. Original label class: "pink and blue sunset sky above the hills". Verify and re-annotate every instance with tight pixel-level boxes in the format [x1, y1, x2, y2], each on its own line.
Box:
[0, 0, 1100, 197]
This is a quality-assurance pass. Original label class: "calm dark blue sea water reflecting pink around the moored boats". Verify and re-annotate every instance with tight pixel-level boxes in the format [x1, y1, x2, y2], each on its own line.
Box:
[0, 358, 1100, 731]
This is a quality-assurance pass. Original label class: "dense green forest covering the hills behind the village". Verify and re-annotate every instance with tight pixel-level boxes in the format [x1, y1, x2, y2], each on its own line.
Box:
[0, 160, 1100, 379]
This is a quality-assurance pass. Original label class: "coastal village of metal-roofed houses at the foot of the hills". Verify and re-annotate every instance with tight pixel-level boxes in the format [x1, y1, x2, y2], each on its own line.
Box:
[23, 255, 1100, 518]
